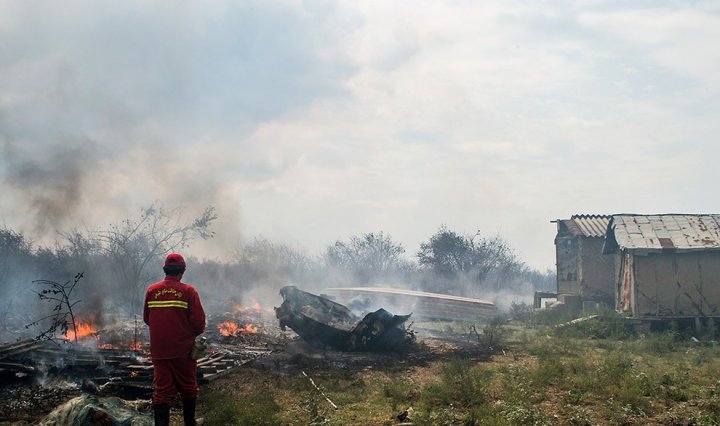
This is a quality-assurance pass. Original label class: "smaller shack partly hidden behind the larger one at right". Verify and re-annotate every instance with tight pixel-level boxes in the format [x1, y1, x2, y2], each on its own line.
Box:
[555, 215, 616, 307]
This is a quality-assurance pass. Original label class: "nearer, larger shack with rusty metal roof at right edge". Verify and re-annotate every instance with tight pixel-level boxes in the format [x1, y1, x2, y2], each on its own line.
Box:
[603, 214, 720, 319]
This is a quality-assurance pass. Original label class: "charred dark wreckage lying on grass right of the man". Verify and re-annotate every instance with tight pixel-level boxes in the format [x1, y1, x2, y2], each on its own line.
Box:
[275, 286, 415, 351]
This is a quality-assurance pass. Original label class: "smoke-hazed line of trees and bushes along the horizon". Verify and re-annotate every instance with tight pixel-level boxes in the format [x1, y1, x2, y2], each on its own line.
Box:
[0, 203, 555, 338]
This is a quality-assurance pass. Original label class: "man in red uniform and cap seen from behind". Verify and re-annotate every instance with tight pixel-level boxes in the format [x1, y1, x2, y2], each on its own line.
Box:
[143, 253, 205, 426]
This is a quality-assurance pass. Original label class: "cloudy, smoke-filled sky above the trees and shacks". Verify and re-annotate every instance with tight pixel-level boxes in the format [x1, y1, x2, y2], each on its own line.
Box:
[0, 0, 720, 271]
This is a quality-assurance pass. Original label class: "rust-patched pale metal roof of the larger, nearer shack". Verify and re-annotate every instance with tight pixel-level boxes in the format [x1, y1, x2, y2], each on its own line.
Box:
[603, 214, 720, 254]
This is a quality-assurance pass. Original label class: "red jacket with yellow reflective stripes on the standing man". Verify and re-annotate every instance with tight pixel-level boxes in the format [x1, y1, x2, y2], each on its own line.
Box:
[143, 276, 205, 359]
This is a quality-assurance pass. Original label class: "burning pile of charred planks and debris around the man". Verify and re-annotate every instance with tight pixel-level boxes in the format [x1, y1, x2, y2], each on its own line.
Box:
[0, 316, 272, 425]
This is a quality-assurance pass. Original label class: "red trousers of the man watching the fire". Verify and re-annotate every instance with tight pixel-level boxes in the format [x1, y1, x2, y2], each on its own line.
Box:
[152, 358, 200, 407]
